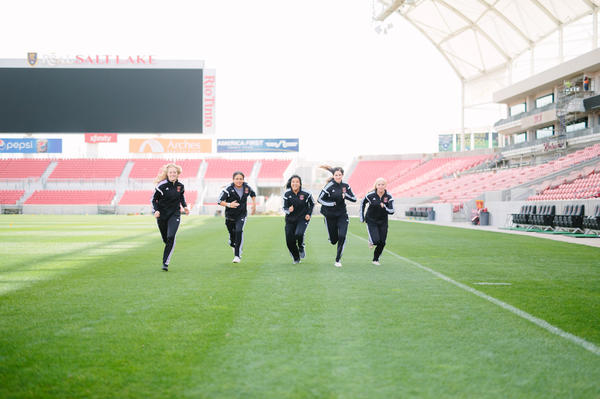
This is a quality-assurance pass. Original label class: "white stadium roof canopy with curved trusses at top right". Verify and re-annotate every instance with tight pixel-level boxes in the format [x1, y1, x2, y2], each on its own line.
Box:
[375, 0, 600, 84]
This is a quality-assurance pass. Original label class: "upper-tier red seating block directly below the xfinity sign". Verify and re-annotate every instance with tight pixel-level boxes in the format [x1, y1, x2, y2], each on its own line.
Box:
[48, 159, 127, 180]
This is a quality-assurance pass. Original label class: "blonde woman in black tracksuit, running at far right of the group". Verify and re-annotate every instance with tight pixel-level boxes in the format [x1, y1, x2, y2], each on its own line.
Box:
[359, 177, 394, 266]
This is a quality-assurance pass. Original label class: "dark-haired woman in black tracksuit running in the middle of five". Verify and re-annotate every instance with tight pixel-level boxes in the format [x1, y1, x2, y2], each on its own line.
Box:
[283, 175, 315, 264]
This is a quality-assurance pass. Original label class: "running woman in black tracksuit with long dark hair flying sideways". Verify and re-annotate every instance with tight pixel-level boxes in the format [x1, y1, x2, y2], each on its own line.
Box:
[318, 165, 356, 267]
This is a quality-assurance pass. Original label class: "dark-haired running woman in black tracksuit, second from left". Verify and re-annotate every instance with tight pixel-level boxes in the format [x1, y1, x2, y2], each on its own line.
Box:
[219, 172, 256, 263]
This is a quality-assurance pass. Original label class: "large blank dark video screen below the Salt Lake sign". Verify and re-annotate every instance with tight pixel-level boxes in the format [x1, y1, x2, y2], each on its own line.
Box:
[0, 67, 202, 133]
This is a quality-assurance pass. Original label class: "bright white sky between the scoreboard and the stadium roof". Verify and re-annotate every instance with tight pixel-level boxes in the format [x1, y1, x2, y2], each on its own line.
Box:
[0, 0, 460, 160]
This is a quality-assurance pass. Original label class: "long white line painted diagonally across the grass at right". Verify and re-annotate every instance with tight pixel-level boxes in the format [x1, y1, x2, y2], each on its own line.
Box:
[349, 233, 600, 356]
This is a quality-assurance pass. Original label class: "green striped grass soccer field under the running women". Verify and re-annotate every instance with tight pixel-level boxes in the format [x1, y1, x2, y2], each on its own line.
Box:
[0, 215, 600, 399]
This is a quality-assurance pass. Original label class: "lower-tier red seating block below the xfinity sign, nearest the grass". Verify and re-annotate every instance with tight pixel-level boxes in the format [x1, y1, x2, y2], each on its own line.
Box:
[25, 190, 115, 205]
